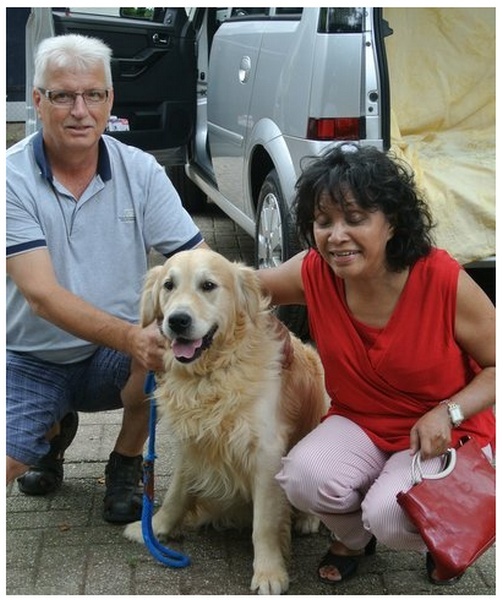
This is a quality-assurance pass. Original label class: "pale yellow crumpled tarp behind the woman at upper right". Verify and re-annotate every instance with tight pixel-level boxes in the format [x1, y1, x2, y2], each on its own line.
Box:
[384, 8, 496, 264]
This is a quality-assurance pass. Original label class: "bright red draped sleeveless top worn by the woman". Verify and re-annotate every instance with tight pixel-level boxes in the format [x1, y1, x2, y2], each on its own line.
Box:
[302, 249, 495, 452]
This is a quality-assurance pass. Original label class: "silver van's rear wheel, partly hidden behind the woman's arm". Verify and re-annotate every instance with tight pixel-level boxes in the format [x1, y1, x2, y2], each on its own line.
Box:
[255, 169, 309, 341]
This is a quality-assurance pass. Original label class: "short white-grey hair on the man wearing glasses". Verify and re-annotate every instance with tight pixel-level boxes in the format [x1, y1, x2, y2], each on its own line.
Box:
[33, 34, 113, 88]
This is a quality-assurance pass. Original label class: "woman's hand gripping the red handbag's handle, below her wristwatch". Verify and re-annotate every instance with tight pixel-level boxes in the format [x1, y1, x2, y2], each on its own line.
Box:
[410, 404, 452, 459]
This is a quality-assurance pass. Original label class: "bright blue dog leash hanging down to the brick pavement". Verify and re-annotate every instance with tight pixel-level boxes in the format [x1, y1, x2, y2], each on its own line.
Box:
[141, 372, 190, 568]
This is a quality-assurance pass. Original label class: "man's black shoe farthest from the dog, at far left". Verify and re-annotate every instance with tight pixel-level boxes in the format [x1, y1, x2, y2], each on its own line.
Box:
[17, 412, 79, 496]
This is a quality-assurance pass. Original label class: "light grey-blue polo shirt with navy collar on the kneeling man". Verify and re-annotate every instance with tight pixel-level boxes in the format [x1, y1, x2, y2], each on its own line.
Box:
[6, 132, 202, 363]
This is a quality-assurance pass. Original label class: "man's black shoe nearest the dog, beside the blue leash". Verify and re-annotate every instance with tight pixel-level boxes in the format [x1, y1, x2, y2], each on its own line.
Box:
[103, 451, 143, 523]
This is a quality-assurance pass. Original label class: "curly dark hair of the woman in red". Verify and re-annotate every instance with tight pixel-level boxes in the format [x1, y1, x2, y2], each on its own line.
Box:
[294, 144, 434, 272]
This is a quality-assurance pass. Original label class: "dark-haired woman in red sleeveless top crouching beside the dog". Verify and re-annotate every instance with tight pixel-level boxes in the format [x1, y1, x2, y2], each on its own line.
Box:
[261, 144, 495, 584]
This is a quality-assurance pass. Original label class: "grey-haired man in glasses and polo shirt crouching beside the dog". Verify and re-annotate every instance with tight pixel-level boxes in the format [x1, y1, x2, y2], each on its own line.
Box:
[6, 35, 206, 523]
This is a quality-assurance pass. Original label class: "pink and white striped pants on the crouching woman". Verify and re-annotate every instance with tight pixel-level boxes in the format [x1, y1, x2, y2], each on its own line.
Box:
[276, 416, 464, 552]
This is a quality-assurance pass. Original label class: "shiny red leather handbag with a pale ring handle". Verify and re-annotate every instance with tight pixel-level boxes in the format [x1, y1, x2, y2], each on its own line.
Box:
[397, 438, 496, 579]
